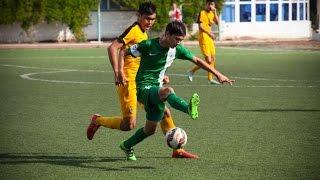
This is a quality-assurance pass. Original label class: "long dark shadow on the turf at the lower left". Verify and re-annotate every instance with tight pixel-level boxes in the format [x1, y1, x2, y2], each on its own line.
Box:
[0, 153, 155, 171]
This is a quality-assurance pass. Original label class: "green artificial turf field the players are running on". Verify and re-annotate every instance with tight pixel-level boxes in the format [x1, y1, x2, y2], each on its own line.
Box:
[0, 46, 320, 179]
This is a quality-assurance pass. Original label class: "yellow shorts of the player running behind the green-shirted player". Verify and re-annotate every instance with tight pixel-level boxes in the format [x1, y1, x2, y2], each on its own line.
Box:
[117, 80, 137, 117]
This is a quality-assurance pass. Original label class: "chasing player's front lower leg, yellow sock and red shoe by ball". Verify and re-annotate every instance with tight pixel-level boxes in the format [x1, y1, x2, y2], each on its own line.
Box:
[160, 107, 198, 159]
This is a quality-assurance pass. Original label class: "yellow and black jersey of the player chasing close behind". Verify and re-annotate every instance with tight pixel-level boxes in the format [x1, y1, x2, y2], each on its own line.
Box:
[118, 22, 148, 80]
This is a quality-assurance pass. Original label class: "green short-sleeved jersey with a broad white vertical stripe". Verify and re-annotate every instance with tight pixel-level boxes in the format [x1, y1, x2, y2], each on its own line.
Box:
[129, 38, 194, 89]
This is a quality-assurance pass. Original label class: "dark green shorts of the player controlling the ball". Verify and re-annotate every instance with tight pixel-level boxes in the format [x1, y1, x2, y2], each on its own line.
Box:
[137, 86, 165, 122]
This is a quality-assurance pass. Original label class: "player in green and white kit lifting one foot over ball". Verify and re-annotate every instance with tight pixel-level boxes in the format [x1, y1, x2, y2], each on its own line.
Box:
[115, 21, 234, 160]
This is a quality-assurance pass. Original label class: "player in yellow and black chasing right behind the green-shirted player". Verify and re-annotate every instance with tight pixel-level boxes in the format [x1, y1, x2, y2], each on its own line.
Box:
[87, 2, 198, 158]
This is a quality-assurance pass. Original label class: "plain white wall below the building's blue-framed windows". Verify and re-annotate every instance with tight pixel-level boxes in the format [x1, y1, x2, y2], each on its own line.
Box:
[220, 21, 312, 40]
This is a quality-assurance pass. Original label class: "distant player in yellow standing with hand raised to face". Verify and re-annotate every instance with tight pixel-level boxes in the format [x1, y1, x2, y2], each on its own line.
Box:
[187, 0, 220, 84]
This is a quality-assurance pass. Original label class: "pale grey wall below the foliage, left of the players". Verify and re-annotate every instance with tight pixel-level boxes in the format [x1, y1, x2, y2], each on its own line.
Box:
[0, 11, 137, 43]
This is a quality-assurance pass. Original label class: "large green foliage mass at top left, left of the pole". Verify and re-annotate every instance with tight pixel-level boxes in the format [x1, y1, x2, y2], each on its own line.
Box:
[0, 0, 98, 41]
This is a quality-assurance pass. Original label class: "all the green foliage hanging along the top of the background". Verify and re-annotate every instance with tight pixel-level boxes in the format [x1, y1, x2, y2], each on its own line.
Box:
[0, 0, 228, 41]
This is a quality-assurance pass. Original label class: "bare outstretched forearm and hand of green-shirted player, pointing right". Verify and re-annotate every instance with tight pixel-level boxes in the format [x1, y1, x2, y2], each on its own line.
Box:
[192, 56, 235, 85]
